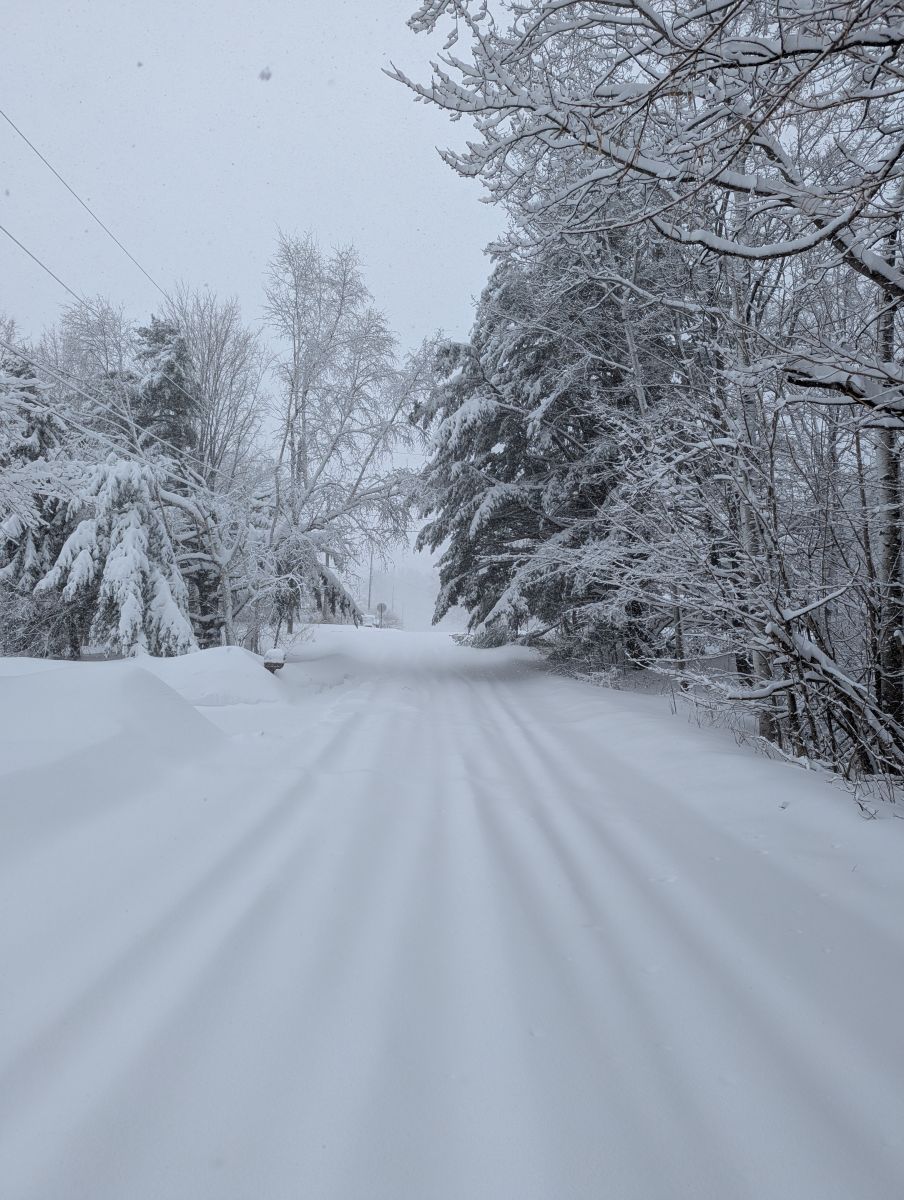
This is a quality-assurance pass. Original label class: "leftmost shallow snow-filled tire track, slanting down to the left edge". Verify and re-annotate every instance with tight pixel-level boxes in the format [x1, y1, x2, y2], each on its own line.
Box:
[0, 681, 388, 1200]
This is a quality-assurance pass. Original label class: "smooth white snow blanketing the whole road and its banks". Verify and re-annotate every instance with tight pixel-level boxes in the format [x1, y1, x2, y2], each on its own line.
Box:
[0, 629, 904, 1200]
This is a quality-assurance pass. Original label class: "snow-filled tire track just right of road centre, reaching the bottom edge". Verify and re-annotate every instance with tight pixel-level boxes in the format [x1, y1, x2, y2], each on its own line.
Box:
[453, 676, 746, 1200]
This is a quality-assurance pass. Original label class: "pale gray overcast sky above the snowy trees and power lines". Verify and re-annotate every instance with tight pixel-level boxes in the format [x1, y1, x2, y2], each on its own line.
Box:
[0, 0, 501, 346]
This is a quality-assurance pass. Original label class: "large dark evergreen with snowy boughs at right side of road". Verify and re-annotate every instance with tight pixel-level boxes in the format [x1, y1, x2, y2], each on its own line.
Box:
[419, 234, 673, 653]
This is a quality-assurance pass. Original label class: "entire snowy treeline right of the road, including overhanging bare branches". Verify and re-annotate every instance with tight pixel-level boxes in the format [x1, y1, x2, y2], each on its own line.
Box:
[397, 0, 904, 775]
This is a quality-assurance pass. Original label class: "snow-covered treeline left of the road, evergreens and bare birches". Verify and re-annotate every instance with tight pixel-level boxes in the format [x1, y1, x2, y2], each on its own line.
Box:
[0, 236, 420, 656]
